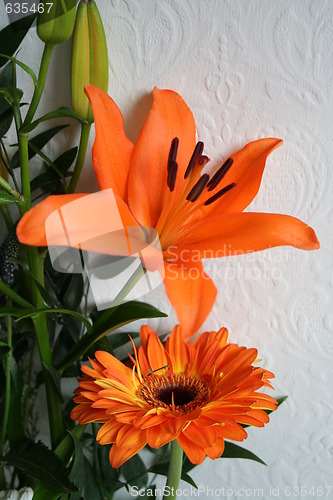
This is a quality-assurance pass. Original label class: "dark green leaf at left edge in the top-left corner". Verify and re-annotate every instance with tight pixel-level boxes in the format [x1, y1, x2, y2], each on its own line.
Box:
[0, 14, 36, 67]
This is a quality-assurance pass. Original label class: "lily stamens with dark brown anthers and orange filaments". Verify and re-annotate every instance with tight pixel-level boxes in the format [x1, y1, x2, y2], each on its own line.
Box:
[156, 137, 236, 250]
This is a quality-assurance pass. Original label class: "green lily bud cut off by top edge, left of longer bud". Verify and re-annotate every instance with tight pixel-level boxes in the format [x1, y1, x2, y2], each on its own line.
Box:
[37, 0, 76, 44]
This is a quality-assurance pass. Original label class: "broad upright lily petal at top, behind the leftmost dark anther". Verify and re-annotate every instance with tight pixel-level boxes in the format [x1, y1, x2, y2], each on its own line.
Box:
[128, 88, 195, 227]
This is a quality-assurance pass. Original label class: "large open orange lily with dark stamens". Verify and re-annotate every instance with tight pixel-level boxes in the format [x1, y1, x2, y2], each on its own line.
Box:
[17, 86, 319, 338]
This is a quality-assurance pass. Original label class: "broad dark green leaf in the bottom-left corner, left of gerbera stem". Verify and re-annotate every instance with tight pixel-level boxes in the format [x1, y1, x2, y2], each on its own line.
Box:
[4, 439, 77, 493]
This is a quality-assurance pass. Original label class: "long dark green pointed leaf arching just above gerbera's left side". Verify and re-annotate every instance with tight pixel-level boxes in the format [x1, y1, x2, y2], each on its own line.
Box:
[58, 302, 167, 371]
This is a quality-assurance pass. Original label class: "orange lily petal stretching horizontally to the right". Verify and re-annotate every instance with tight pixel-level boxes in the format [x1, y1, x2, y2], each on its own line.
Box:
[173, 212, 319, 259]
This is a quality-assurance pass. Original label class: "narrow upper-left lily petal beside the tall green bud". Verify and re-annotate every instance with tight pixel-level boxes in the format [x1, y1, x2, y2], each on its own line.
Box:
[85, 85, 133, 201]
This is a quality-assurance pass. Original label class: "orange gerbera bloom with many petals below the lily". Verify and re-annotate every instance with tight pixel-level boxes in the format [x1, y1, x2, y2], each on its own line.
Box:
[71, 326, 277, 468]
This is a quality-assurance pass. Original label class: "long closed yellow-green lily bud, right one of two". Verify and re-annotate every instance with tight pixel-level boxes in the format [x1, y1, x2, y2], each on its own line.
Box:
[71, 0, 109, 123]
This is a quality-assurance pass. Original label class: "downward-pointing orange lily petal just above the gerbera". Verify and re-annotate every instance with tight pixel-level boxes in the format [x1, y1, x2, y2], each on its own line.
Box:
[164, 262, 216, 339]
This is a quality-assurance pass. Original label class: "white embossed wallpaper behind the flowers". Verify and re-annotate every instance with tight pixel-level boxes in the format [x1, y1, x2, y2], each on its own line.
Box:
[1, 0, 333, 500]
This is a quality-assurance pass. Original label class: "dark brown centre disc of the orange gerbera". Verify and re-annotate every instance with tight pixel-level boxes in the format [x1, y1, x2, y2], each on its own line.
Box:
[138, 373, 210, 413]
